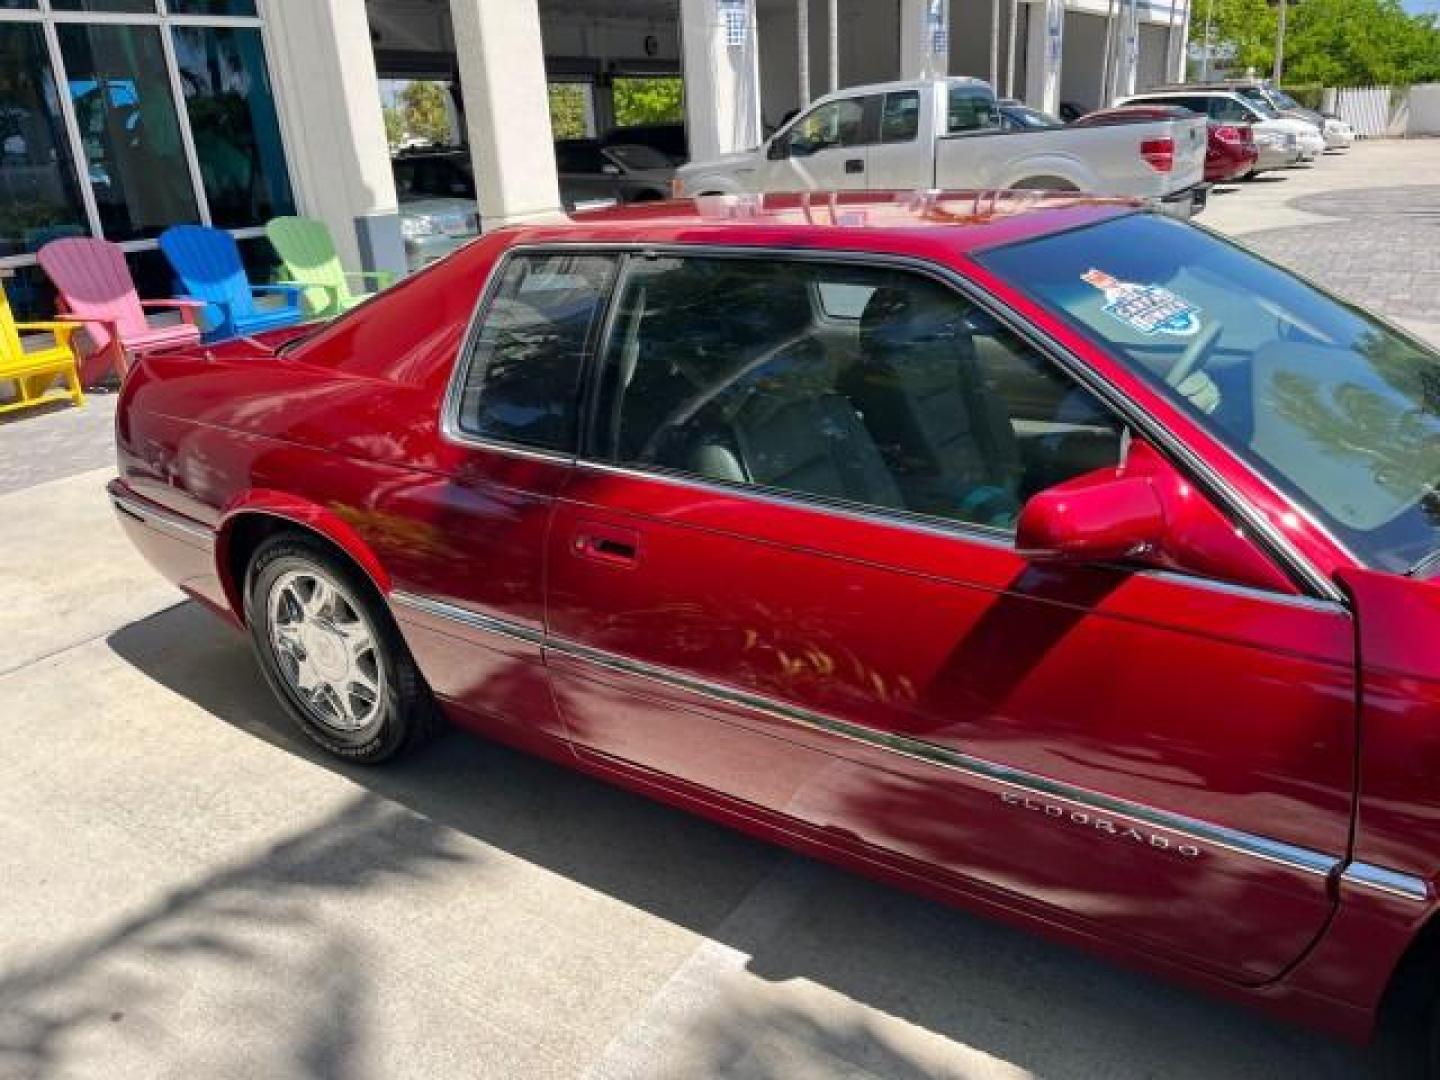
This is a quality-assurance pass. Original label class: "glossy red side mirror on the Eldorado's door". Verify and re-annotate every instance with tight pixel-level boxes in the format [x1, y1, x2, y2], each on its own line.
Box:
[1015, 477, 1165, 563]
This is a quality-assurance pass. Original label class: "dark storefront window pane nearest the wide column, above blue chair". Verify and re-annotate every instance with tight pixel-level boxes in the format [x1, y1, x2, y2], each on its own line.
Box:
[171, 25, 295, 229]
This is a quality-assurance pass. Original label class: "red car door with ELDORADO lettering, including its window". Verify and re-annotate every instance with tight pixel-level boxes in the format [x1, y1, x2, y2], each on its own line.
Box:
[547, 253, 1355, 982]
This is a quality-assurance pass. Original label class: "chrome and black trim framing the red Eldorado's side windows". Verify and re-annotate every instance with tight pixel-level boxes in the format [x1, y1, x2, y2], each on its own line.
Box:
[441, 240, 1349, 612]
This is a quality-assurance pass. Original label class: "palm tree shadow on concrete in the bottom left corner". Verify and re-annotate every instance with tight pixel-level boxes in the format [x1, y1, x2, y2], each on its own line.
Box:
[0, 792, 455, 1079]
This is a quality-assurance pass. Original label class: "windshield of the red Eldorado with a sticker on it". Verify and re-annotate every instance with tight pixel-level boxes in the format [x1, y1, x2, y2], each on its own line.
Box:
[979, 215, 1440, 570]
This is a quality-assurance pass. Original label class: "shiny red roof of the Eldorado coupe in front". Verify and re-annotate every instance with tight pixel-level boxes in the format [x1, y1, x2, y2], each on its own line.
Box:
[504, 190, 1143, 252]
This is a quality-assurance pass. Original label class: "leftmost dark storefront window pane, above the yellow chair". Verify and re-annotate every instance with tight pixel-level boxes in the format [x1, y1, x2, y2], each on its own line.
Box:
[0, 23, 86, 256]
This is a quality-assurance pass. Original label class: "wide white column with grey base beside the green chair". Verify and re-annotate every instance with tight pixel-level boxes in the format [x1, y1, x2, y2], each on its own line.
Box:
[265, 0, 406, 274]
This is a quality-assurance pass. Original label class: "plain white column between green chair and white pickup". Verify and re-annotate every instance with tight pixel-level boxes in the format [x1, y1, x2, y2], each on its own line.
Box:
[449, 0, 560, 230]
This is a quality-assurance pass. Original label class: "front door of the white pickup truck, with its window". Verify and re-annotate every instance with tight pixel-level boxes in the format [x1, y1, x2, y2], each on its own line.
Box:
[762, 95, 880, 192]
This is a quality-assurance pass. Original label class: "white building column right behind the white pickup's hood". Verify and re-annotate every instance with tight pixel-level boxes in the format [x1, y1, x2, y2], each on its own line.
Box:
[680, 0, 763, 161]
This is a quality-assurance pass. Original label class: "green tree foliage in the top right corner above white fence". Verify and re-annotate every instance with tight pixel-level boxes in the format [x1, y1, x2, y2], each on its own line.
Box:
[1209, 0, 1440, 86]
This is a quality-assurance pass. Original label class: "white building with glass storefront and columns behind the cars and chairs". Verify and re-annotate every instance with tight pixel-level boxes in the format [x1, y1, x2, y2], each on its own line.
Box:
[0, 0, 1188, 311]
